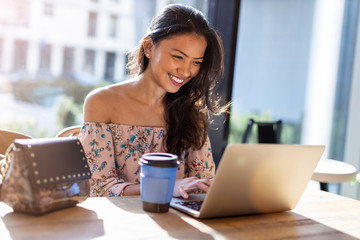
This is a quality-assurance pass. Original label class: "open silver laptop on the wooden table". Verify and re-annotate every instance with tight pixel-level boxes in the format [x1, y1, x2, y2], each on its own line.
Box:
[170, 144, 325, 218]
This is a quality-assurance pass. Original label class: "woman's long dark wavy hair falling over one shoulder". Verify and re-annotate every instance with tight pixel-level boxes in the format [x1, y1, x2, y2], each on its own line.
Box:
[127, 4, 228, 156]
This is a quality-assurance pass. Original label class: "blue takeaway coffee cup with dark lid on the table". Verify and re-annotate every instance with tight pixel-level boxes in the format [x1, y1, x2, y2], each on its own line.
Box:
[139, 153, 179, 213]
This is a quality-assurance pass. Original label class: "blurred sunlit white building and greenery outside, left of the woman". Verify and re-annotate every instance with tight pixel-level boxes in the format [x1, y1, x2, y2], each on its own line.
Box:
[0, 0, 207, 137]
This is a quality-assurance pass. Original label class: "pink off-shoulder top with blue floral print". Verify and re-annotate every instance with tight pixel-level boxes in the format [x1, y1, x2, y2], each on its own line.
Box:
[79, 122, 215, 197]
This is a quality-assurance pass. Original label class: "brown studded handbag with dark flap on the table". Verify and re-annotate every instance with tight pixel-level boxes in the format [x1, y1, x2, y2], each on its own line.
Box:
[0, 137, 91, 215]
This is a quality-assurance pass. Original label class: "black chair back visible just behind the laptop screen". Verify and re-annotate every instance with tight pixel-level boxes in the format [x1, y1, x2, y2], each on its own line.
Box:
[242, 118, 282, 143]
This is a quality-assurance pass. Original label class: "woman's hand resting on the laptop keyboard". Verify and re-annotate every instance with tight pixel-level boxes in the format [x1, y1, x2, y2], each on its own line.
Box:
[173, 177, 212, 198]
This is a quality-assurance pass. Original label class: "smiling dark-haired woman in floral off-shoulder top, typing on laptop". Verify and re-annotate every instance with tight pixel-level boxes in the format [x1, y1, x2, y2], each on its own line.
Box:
[79, 4, 226, 198]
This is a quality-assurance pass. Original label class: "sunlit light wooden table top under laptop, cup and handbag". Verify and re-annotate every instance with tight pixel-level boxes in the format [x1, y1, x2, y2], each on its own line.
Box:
[0, 189, 360, 240]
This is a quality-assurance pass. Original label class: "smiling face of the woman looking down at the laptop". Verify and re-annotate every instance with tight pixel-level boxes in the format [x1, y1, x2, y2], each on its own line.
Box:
[147, 33, 207, 93]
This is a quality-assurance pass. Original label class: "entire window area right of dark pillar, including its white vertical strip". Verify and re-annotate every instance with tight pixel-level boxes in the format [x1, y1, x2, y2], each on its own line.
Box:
[229, 0, 359, 195]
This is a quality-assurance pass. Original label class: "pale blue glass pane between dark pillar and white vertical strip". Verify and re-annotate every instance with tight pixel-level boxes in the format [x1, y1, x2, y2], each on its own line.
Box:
[230, 0, 314, 143]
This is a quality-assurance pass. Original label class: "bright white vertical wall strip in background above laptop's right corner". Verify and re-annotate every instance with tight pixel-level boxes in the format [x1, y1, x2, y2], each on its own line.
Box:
[302, 0, 345, 157]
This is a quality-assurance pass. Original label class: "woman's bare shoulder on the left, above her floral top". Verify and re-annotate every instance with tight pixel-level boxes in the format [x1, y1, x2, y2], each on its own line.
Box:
[84, 82, 136, 122]
